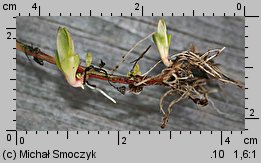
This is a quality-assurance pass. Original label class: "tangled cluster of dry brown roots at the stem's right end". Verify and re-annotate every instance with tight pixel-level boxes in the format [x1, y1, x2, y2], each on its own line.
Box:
[135, 47, 243, 128]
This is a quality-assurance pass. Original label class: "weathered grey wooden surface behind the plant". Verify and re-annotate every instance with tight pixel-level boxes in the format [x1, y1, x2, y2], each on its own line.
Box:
[16, 17, 245, 130]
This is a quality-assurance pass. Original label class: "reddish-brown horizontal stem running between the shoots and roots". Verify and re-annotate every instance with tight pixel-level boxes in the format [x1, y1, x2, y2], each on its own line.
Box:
[16, 41, 162, 86]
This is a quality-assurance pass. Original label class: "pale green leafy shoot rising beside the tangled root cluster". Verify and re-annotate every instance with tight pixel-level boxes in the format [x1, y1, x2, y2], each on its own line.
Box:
[152, 19, 171, 67]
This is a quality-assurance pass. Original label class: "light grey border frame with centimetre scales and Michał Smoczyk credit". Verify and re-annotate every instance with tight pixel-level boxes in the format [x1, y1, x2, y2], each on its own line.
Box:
[0, 0, 261, 162]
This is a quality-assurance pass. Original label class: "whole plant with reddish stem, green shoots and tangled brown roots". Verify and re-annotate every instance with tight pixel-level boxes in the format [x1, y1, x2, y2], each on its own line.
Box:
[16, 19, 243, 128]
